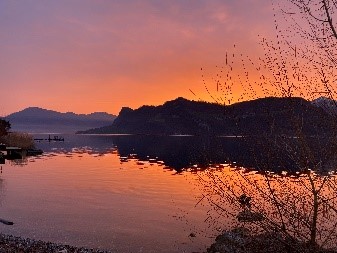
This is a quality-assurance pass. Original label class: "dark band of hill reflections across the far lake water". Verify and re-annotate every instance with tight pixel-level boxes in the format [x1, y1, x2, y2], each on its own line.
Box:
[33, 135, 337, 172]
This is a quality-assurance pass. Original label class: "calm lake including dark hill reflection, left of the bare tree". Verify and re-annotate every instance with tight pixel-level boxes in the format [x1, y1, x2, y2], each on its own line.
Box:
[0, 135, 335, 252]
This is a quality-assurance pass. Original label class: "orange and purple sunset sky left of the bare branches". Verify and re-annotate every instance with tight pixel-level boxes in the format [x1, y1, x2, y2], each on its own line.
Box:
[0, 0, 274, 116]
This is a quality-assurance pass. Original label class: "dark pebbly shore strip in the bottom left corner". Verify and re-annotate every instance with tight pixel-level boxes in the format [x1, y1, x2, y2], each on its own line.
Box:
[0, 234, 111, 253]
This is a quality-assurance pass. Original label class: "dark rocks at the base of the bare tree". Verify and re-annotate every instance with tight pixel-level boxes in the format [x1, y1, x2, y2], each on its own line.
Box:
[207, 228, 337, 253]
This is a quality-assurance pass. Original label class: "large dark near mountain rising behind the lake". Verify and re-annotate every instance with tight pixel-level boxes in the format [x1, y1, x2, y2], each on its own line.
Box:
[78, 97, 334, 135]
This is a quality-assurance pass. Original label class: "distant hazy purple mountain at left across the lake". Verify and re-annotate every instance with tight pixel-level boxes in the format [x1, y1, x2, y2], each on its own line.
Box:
[5, 107, 116, 133]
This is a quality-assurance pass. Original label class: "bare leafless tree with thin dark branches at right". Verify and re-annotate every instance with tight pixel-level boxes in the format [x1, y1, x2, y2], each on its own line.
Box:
[199, 0, 337, 252]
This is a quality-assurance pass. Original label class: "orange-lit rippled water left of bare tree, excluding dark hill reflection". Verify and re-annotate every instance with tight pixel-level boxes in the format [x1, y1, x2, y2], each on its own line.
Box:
[0, 136, 218, 252]
